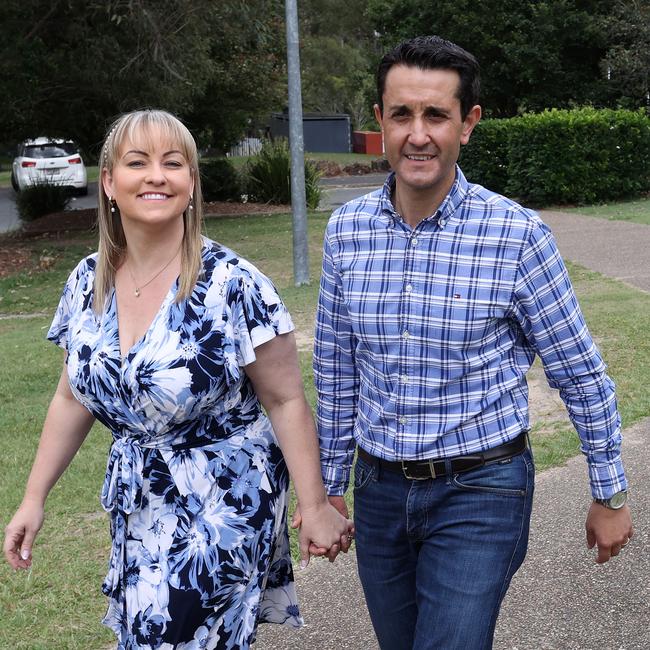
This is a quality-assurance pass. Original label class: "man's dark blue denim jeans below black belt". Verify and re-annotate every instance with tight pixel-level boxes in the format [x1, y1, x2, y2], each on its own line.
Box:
[354, 449, 535, 650]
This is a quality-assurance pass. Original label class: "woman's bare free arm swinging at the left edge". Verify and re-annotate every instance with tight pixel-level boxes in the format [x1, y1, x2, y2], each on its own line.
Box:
[3, 367, 94, 569]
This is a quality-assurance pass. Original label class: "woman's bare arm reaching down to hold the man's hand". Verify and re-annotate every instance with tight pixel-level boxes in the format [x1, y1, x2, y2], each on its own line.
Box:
[244, 333, 352, 564]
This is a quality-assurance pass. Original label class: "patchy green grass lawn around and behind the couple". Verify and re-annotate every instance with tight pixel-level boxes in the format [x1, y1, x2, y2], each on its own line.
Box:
[0, 213, 650, 650]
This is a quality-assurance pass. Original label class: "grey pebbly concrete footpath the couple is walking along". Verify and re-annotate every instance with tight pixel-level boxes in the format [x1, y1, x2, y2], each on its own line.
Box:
[254, 211, 650, 650]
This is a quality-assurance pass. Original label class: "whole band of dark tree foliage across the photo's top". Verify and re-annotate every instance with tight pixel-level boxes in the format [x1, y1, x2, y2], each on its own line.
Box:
[0, 0, 650, 167]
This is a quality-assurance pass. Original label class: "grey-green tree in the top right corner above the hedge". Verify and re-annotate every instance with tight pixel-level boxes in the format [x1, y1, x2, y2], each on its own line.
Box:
[602, 0, 650, 108]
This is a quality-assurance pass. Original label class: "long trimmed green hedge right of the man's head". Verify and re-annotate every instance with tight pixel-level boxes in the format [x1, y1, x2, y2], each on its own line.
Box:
[460, 108, 650, 205]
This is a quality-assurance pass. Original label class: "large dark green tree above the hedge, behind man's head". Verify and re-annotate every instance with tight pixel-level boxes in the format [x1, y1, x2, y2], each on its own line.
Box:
[368, 0, 610, 117]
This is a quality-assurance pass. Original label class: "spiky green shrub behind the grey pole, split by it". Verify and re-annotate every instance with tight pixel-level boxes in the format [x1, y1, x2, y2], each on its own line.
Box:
[247, 139, 321, 210]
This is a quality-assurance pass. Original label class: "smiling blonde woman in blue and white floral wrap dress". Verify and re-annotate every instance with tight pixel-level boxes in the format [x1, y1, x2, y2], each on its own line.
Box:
[4, 110, 352, 649]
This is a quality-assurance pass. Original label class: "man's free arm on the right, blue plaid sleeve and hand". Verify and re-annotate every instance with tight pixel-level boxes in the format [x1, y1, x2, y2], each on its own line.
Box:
[515, 223, 632, 562]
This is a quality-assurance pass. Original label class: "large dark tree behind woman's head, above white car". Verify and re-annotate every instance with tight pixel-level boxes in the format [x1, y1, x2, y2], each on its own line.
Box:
[0, 0, 282, 153]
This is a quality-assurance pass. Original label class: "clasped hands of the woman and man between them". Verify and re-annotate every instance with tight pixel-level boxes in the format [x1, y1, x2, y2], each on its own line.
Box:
[291, 497, 354, 569]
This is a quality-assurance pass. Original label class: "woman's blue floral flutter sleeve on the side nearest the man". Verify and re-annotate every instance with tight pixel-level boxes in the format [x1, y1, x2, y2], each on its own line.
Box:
[226, 260, 294, 366]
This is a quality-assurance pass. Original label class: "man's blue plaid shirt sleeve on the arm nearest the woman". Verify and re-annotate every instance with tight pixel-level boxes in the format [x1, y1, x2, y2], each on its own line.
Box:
[314, 225, 359, 496]
